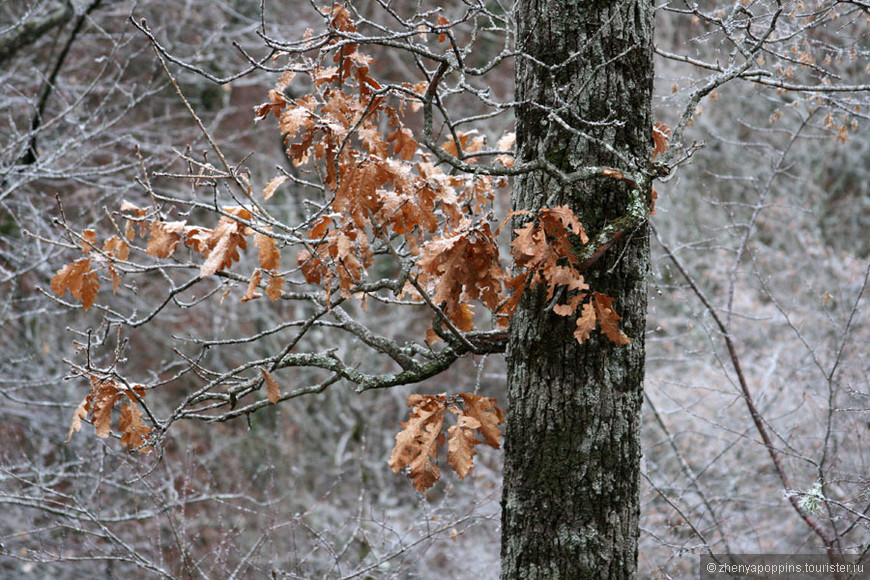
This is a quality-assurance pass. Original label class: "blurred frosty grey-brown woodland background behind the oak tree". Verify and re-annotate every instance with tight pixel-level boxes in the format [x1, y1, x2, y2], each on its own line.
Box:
[0, 0, 870, 578]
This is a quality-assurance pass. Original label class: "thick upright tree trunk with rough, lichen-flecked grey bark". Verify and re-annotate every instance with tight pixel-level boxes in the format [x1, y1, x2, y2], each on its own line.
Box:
[502, 0, 653, 580]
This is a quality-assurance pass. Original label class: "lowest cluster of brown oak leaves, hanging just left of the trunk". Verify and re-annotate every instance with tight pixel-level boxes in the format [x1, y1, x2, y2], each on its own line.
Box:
[390, 393, 504, 492]
